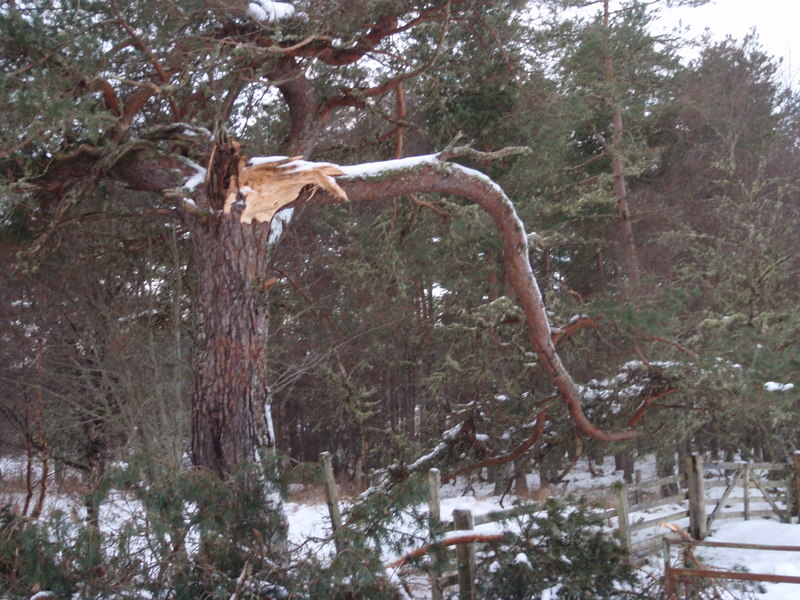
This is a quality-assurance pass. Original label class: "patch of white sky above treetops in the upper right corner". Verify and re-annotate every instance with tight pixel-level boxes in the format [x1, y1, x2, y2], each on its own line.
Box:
[661, 0, 800, 88]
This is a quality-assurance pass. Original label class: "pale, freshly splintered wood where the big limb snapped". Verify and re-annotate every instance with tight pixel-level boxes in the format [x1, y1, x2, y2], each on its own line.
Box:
[225, 156, 347, 223]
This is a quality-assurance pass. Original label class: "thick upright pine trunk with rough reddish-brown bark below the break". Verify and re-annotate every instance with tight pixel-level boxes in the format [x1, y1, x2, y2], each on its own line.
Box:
[187, 211, 274, 477]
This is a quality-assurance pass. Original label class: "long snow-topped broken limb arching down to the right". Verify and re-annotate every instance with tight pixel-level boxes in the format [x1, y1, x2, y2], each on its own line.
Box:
[299, 154, 639, 441]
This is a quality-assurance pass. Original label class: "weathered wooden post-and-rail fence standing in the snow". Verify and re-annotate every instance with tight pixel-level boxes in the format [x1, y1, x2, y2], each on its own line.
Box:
[320, 452, 800, 600]
